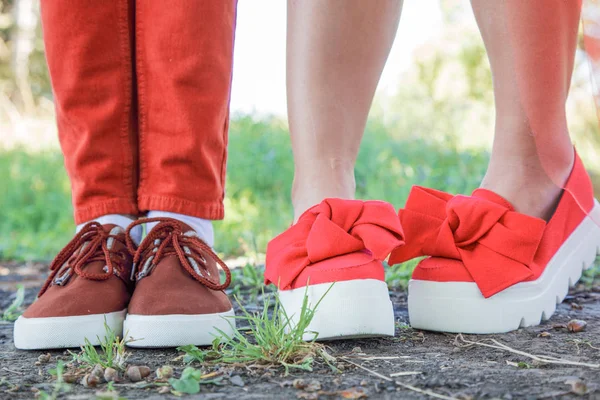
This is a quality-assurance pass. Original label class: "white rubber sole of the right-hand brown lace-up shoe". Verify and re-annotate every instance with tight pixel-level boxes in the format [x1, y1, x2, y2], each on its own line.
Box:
[123, 309, 235, 348]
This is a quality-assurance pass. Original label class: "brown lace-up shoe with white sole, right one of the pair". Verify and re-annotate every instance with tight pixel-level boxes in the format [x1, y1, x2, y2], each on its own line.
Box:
[124, 218, 235, 347]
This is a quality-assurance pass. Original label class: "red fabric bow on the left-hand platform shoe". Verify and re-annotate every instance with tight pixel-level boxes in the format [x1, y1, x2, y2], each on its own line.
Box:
[265, 199, 404, 289]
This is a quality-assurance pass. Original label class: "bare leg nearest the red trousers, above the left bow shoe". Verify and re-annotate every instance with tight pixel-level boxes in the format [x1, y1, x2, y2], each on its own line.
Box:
[287, 0, 402, 219]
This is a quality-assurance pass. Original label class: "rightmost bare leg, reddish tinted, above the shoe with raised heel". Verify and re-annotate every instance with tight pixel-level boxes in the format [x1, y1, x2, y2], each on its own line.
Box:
[471, 0, 581, 219]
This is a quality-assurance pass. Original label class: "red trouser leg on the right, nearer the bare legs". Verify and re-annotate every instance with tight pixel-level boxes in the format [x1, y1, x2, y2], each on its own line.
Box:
[135, 0, 236, 219]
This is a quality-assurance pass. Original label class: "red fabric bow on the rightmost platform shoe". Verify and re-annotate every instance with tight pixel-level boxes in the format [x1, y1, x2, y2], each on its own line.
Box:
[390, 186, 546, 297]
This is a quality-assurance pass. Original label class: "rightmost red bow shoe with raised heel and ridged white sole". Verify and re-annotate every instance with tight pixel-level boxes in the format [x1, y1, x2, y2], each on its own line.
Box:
[390, 150, 600, 333]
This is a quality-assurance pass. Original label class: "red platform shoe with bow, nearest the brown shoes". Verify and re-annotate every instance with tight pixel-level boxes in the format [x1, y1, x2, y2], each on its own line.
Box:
[265, 199, 404, 340]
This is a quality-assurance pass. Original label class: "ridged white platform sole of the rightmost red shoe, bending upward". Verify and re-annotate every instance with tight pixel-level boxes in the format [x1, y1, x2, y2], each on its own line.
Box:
[408, 202, 600, 333]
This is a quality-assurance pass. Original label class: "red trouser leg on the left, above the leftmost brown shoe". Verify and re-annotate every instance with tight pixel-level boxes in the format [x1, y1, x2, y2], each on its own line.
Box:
[41, 0, 137, 223]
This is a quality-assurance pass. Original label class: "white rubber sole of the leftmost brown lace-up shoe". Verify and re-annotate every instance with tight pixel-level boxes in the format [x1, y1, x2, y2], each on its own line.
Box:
[14, 310, 127, 350]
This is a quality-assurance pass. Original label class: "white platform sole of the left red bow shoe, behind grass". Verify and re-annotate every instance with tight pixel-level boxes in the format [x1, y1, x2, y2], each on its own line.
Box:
[279, 279, 394, 340]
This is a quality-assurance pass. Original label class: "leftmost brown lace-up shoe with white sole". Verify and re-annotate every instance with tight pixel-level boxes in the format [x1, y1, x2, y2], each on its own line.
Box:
[14, 222, 132, 349]
